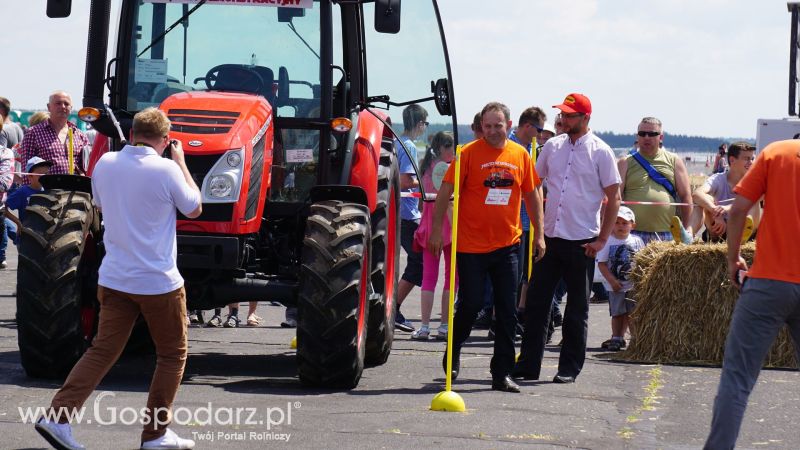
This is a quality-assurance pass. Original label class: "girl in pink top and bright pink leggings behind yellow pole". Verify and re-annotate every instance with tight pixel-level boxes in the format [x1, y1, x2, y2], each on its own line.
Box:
[411, 131, 458, 340]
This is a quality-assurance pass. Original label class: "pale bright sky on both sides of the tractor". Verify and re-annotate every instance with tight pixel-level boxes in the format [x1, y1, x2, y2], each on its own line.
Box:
[0, 0, 789, 137]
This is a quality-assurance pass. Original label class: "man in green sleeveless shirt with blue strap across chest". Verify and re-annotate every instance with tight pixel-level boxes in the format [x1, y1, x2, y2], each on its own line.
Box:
[617, 117, 692, 244]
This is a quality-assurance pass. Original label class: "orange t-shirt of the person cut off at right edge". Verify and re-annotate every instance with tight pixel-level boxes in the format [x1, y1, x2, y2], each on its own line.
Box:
[734, 140, 800, 283]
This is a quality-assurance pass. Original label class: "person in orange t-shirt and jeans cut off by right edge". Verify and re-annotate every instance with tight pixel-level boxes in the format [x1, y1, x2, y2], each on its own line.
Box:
[705, 140, 800, 449]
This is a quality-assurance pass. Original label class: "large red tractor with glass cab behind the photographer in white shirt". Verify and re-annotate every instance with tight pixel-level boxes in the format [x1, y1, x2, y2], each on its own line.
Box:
[17, 0, 455, 388]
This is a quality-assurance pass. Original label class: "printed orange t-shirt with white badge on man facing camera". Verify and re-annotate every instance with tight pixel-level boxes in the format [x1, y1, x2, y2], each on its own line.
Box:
[443, 139, 541, 253]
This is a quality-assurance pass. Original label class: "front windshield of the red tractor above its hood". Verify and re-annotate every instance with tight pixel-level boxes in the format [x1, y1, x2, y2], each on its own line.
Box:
[127, 0, 321, 118]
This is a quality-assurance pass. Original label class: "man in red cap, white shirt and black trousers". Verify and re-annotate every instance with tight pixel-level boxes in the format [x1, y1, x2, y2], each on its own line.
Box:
[512, 94, 620, 383]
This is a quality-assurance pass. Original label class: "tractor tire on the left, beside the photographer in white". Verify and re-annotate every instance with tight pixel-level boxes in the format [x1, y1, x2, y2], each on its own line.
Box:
[17, 189, 99, 378]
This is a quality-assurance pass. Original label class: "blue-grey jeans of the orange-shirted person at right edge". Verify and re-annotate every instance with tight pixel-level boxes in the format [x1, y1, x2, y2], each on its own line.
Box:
[705, 278, 800, 450]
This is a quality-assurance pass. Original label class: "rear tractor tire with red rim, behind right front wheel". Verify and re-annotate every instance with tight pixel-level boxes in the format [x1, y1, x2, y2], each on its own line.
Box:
[366, 144, 400, 365]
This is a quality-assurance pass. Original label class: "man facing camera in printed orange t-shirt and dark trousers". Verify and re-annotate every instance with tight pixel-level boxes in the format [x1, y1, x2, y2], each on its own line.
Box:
[428, 102, 545, 392]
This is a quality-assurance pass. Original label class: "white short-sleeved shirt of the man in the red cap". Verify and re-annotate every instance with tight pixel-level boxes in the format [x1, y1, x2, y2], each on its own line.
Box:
[536, 131, 620, 241]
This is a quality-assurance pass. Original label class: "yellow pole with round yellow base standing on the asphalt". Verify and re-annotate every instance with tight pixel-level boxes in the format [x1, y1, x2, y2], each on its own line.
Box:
[431, 145, 466, 412]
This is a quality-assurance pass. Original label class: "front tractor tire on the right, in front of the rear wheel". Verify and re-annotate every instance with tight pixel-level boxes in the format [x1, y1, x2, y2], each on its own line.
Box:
[297, 200, 371, 389]
